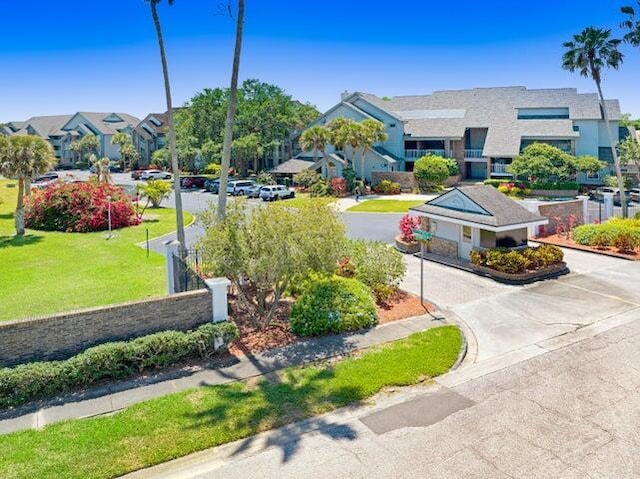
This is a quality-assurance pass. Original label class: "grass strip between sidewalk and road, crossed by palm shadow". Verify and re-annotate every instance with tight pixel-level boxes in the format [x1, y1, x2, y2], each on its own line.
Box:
[0, 326, 461, 479]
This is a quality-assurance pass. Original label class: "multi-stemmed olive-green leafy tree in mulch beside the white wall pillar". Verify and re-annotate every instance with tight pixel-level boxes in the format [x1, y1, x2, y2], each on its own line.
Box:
[198, 200, 346, 329]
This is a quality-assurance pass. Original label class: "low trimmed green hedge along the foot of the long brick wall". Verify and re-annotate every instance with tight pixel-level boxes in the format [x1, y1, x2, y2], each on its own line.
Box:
[0, 321, 238, 408]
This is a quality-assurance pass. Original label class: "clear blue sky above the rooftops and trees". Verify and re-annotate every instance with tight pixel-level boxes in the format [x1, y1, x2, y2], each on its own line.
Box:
[0, 0, 640, 121]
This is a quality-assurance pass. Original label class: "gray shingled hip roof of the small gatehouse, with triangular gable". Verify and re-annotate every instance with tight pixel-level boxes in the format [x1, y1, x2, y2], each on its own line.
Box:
[411, 185, 547, 228]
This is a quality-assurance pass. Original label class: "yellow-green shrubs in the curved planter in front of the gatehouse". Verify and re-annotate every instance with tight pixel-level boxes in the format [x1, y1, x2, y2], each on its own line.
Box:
[471, 245, 564, 274]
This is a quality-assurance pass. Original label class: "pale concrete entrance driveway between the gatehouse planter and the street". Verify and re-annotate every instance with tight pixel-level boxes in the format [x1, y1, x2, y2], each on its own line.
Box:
[402, 250, 640, 361]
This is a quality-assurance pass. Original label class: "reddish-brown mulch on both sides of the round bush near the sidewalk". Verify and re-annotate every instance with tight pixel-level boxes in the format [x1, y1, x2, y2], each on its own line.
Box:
[229, 291, 436, 356]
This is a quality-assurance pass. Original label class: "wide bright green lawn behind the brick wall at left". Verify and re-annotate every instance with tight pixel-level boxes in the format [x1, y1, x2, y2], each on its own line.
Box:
[0, 180, 192, 321]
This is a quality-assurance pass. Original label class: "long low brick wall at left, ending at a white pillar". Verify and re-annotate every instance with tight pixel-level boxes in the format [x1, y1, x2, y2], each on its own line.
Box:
[0, 289, 212, 366]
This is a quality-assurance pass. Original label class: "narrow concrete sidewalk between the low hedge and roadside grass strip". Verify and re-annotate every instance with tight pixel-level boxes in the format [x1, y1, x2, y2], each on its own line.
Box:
[0, 314, 446, 434]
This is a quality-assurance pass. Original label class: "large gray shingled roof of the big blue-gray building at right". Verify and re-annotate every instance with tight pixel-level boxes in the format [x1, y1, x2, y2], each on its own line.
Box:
[349, 87, 621, 157]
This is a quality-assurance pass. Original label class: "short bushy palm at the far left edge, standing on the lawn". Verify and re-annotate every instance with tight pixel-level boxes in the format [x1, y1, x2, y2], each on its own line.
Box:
[0, 135, 57, 236]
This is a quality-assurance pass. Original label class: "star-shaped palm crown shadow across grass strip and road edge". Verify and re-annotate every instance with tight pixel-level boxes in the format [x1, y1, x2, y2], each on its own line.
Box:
[190, 352, 365, 463]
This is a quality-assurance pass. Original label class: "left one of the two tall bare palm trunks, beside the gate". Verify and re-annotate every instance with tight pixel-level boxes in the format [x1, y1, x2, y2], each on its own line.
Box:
[145, 0, 185, 248]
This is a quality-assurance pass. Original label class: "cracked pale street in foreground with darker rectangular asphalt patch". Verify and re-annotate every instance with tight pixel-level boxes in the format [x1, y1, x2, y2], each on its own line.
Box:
[127, 320, 640, 479]
